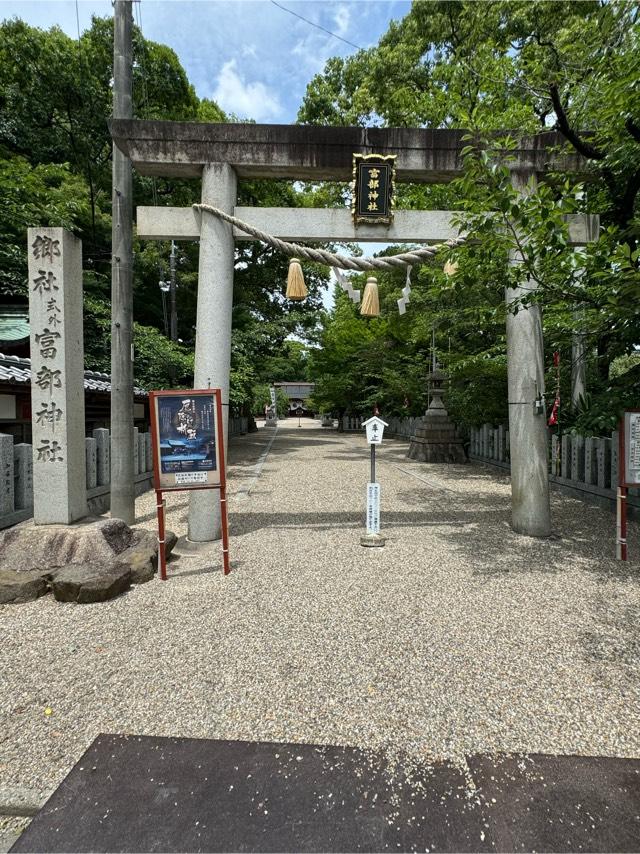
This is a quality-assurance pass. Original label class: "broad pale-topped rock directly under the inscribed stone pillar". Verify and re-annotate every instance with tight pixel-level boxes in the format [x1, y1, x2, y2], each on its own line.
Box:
[0, 518, 133, 572]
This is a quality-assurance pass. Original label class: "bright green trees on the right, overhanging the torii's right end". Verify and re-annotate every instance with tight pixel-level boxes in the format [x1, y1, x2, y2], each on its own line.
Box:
[298, 0, 640, 432]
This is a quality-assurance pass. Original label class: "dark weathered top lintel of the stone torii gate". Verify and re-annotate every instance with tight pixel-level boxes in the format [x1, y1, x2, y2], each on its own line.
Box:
[109, 119, 586, 184]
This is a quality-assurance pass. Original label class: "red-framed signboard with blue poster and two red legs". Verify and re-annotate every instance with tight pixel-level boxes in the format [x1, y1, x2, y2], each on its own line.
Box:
[149, 388, 229, 581]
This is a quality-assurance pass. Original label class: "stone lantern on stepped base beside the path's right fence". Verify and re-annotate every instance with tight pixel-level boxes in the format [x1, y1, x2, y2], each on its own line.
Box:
[407, 363, 467, 463]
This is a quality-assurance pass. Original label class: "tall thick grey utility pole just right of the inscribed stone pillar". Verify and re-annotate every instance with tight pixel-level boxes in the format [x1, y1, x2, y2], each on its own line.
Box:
[111, 0, 135, 525]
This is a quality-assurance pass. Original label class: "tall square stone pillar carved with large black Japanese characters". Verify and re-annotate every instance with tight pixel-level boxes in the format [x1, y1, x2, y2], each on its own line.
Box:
[28, 228, 87, 525]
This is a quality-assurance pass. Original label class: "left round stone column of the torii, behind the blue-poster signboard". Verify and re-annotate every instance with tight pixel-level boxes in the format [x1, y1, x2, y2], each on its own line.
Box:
[188, 163, 237, 542]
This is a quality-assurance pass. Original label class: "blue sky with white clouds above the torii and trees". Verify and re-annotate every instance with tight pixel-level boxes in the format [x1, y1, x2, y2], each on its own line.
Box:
[0, 0, 410, 124]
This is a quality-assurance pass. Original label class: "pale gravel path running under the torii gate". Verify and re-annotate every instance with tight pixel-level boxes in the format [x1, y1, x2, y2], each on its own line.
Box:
[0, 422, 640, 804]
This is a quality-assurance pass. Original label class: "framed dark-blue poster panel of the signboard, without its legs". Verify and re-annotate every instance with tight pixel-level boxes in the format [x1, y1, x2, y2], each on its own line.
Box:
[150, 389, 220, 490]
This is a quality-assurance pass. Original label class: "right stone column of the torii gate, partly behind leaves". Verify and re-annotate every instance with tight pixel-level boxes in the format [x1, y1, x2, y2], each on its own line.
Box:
[506, 173, 551, 537]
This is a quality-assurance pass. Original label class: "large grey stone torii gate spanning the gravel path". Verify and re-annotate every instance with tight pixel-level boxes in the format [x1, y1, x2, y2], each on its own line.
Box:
[110, 119, 594, 542]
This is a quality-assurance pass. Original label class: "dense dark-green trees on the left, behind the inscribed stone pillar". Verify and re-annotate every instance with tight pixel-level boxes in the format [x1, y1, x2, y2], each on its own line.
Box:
[0, 12, 326, 402]
